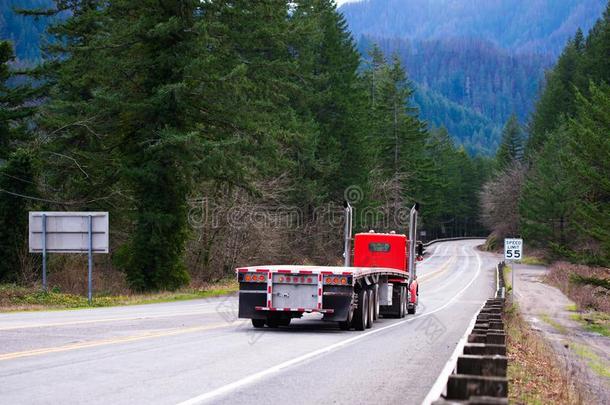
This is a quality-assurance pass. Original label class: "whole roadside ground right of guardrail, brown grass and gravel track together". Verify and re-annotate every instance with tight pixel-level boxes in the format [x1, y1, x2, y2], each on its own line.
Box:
[505, 264, 610, 404]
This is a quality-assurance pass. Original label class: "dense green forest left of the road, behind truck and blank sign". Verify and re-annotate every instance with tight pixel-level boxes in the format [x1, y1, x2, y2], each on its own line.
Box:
[0, 0, 489, 290]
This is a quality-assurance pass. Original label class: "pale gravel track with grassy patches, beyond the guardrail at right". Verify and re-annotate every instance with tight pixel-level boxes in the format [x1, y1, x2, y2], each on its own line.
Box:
[508, 264, 610, 404]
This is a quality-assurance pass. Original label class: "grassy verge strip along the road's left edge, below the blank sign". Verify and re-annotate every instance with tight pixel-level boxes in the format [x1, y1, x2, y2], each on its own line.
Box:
[0, 279, 238, 312]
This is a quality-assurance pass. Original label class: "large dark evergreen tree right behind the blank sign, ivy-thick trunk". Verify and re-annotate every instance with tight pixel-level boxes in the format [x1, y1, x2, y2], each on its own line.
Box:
[32, 0, 216, 290]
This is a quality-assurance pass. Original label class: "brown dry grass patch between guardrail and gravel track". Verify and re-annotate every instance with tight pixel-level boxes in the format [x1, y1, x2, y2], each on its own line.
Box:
[504, 304, 582, 405]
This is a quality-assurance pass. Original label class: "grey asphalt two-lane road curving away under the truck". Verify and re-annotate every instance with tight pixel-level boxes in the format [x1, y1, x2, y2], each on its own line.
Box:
[0, 240, 497, 404]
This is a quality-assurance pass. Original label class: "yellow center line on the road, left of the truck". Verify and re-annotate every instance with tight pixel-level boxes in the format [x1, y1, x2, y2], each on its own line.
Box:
[0, 322, 230, 361]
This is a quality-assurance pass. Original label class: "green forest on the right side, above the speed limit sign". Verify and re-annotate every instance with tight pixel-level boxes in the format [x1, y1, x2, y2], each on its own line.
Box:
[482, 4, 610, 267]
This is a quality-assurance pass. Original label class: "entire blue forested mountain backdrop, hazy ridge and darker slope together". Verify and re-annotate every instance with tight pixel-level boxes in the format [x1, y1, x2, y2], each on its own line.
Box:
[340, 0, 605, 154]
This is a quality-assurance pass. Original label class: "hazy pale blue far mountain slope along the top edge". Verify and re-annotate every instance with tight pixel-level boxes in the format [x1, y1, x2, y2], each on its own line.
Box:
[340, 0, 607, 55]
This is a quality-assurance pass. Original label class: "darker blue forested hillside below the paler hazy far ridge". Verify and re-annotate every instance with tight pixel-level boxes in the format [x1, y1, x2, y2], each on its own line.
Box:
[359, 37, 553, 154]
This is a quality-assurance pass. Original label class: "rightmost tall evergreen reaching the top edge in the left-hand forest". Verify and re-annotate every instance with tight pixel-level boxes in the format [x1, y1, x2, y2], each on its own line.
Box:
[292, 0, 370, 201]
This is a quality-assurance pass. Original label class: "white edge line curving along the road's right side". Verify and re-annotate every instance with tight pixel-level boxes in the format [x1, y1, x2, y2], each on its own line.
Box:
[177, 243, 484, 405]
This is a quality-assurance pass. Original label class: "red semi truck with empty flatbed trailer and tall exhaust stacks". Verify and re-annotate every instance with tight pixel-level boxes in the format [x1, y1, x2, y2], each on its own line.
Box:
[236, 203, 419, 330]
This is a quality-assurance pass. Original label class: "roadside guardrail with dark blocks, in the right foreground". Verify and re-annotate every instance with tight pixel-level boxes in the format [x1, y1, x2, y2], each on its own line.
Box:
[432, 262, 508, 405]
